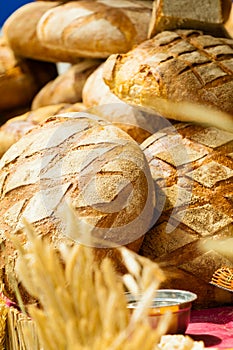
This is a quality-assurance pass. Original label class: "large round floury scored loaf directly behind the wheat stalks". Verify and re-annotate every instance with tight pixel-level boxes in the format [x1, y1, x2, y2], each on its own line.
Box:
[0, 112, 155, 301]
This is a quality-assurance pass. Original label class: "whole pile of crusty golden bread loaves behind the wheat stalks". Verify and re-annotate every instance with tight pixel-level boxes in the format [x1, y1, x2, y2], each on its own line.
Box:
[0, 0, 233, 326]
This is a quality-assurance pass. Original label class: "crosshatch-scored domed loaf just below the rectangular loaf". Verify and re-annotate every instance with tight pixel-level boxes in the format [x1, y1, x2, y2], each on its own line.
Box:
[103, 29, 233, 122]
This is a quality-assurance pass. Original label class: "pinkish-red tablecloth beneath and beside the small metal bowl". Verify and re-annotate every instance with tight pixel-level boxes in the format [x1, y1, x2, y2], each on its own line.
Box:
[186, 306, 233, 349]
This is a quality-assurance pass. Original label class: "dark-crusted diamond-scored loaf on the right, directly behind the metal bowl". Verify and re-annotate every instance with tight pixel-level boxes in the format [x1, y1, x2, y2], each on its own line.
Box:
[140, 123, 233, 307]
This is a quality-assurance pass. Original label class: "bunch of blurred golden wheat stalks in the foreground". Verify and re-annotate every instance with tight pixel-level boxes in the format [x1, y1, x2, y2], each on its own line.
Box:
[7, 208, 208, 350]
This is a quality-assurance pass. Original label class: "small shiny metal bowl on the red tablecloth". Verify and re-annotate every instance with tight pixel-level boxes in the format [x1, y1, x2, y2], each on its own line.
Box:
[126, 289, 197, 334]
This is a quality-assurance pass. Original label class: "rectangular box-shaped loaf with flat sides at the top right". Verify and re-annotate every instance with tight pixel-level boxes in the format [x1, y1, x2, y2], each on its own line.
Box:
[149, 0, 232, 37]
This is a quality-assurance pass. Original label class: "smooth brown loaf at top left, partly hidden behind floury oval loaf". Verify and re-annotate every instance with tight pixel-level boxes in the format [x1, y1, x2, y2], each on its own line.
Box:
[3, 1, 83, 63]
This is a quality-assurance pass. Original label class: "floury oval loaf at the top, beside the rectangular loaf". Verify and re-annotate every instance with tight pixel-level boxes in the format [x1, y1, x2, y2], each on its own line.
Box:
[37, 0, 153, 58]
